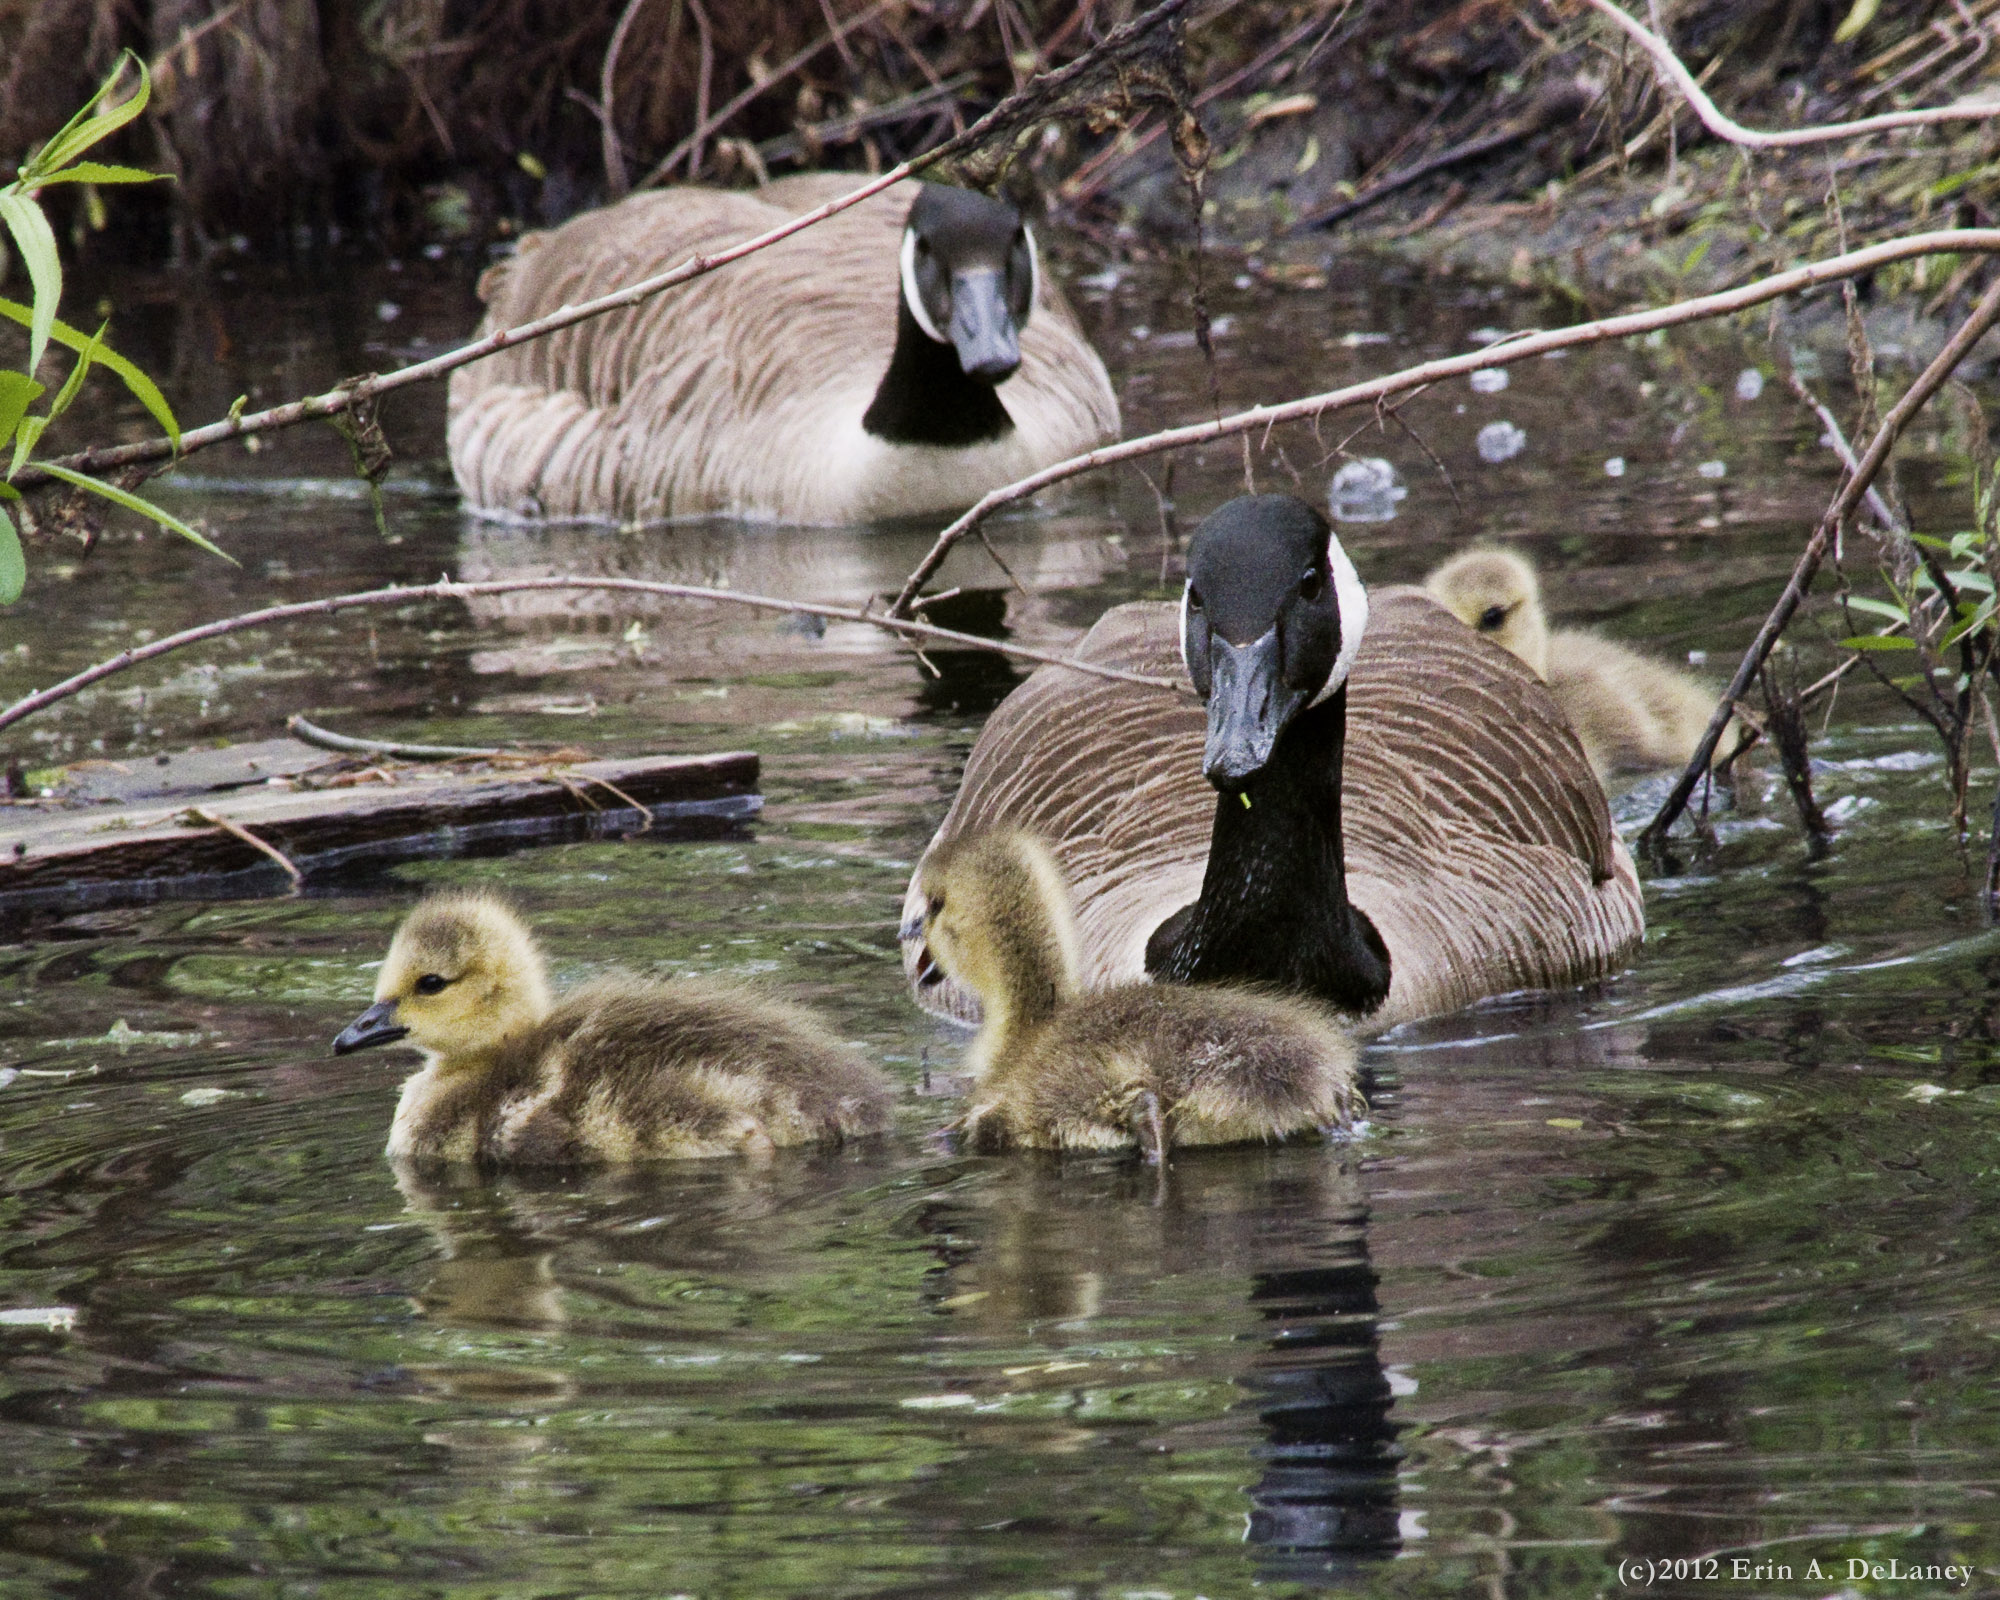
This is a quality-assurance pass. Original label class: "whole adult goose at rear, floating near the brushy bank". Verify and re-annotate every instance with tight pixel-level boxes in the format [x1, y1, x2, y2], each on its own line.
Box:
[450, 174, 1118, 522]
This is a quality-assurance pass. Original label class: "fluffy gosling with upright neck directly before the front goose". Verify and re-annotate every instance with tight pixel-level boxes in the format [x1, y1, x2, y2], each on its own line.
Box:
[904, 830, 1360, 1162]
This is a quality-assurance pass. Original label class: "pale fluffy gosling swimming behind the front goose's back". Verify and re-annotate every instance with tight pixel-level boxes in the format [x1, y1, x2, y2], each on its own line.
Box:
[1424, 548, 1716, 778]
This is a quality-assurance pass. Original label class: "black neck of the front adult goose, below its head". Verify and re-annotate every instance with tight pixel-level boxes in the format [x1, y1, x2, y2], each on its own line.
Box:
[1146, 684, 1388, 1014]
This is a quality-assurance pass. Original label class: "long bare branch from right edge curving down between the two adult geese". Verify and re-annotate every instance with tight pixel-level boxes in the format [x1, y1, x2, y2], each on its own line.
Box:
[890, 228, 2000, 616]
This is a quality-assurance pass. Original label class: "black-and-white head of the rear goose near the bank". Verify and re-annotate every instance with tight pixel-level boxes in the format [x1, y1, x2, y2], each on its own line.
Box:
[902, 184, 1040, 384]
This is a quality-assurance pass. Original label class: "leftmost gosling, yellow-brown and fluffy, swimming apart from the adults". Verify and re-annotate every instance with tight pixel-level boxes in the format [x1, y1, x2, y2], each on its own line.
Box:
[334, 894, 890, 1166]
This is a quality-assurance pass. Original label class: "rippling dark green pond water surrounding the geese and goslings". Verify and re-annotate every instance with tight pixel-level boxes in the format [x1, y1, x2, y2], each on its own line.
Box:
[0, 253, 2000, 1600]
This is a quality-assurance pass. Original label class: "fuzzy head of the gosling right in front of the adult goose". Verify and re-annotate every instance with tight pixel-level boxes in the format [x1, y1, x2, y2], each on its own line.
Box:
[902, 830, 1080, 1016]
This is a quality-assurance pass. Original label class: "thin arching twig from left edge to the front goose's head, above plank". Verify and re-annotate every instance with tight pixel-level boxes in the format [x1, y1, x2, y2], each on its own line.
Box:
[0, 578, 1186, 728]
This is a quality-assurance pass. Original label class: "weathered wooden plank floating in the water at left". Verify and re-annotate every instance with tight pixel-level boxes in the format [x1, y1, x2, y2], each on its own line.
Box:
[0, 750, 762, 918]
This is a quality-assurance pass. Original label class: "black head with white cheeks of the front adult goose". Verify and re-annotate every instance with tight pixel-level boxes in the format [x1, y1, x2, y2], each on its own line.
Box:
[1180, 494, 1368, 794]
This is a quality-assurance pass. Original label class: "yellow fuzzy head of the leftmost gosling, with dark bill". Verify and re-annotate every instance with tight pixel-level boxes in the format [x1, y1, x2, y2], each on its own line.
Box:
[334, 894, 548, 1064]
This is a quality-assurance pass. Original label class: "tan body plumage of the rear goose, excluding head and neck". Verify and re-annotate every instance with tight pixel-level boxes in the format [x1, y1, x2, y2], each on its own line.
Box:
[448, 174, 1118, 522]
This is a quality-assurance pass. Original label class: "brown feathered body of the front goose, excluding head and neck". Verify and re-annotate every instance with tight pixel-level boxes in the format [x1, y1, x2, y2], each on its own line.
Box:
[906, 588, 1644, 1028]
